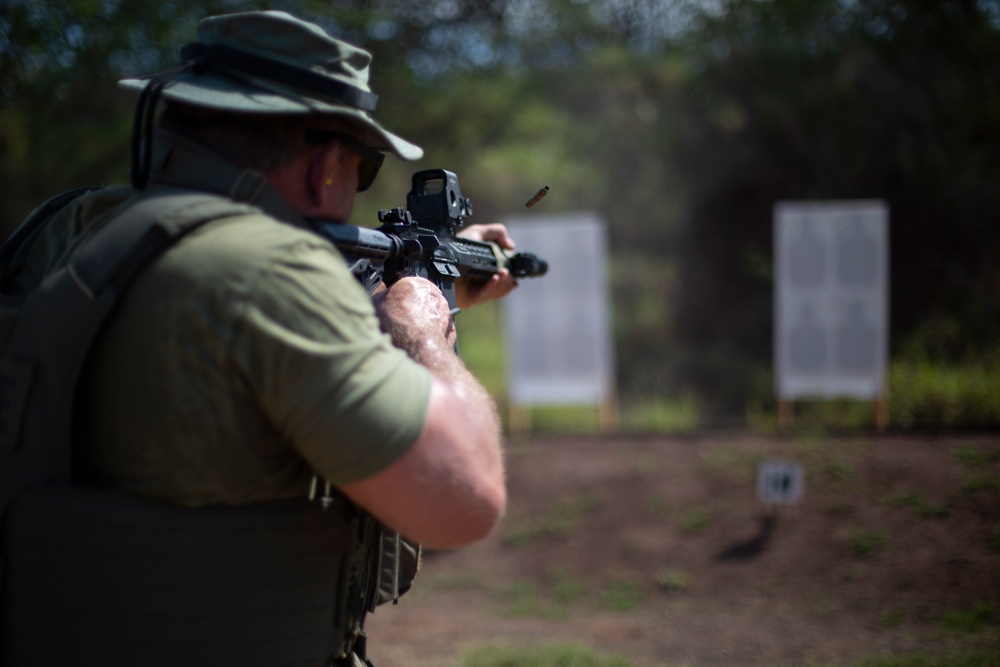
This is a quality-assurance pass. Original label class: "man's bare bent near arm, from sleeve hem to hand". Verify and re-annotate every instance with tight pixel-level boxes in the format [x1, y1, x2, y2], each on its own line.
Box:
[341, 278, 506, 549]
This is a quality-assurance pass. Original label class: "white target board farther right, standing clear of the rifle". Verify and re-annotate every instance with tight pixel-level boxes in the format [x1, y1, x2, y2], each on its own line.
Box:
[774, 200, 889, 400]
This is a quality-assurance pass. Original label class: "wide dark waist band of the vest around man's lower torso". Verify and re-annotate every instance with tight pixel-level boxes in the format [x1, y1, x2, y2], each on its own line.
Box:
[0, 485, 377, 667]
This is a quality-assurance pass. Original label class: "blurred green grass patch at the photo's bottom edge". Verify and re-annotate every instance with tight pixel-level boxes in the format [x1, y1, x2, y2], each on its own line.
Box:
[461, 643, 637, 667]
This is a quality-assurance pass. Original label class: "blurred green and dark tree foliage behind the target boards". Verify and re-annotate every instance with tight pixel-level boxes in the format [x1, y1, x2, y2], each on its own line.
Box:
[0, 0, 1000, 427]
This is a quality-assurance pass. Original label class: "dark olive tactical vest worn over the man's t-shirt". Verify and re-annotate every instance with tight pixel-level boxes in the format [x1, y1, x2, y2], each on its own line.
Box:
[0, 183, 419, 667]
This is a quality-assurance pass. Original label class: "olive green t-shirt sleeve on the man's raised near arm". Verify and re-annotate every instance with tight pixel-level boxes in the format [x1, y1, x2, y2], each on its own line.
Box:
[232, 243, 431, 484]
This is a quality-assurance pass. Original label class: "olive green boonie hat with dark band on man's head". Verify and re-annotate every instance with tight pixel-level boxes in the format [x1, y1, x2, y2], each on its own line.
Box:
[118, 11, 424, 160]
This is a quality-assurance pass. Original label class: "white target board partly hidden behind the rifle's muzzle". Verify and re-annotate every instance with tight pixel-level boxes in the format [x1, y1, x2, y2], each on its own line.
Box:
[501, 212, 614, 406]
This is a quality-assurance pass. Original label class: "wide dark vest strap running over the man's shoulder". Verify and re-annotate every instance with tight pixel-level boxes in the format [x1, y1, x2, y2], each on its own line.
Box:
[0, 191, 257, 515]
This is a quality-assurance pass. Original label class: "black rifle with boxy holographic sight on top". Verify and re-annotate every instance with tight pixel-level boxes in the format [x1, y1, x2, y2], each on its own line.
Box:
[310, 169, 548, 313]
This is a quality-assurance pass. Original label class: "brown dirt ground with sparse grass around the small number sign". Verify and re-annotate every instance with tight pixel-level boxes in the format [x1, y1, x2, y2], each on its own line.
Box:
[368, 433, 1000, 667]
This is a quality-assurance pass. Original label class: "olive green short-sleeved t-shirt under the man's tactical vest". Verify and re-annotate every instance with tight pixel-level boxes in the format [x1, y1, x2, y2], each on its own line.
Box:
[27, 185, 430, 507]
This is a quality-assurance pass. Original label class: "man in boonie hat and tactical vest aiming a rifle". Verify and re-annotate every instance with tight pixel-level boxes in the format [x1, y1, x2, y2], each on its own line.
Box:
[0, 11, 532, 667]
